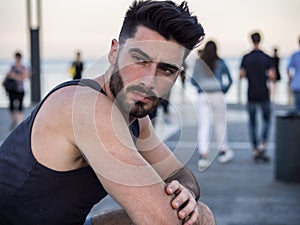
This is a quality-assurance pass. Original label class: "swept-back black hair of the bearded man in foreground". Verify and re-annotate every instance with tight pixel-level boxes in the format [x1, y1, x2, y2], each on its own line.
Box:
[119, 0, 204, 50]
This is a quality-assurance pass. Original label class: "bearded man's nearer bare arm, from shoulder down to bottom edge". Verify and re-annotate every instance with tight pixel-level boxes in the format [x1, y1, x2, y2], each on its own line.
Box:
[72, 88, 181, 225]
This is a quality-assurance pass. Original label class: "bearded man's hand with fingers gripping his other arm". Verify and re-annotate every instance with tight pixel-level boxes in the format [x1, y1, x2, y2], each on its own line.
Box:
[166, 180, 199, 225]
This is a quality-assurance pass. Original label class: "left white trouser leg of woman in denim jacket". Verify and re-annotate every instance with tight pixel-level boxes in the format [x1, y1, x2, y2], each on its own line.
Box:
[197, 93, 211, 155]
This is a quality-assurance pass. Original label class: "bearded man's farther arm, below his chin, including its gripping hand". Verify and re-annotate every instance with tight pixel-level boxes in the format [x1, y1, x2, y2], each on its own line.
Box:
[137, 117, 199, 224]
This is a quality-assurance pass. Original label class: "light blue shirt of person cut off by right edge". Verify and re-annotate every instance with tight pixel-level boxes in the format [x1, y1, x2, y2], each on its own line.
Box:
[287, 36, 300, 112]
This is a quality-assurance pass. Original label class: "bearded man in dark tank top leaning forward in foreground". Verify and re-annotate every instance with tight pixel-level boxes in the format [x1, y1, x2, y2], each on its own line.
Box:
[0, 1, 215, 225]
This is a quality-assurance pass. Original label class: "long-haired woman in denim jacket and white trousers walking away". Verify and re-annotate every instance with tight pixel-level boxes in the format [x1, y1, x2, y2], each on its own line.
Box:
[192, 41, 234, 170]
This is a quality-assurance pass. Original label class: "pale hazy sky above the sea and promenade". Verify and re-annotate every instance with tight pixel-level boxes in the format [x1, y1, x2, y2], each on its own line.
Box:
[0, 0, 300, 60]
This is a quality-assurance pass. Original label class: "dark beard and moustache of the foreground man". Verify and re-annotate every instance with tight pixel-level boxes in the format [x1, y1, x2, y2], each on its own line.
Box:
[109, 66, 162, 118]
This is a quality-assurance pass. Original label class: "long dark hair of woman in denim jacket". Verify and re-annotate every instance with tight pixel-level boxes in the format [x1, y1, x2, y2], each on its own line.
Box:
[201, 41, 219, 72]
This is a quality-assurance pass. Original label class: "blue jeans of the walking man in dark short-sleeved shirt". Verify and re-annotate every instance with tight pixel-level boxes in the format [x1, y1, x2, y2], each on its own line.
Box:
[248, 101, 271, 148]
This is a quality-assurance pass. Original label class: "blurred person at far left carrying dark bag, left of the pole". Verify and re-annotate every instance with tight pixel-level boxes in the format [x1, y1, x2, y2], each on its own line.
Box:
[5, 52, 29, 129]
